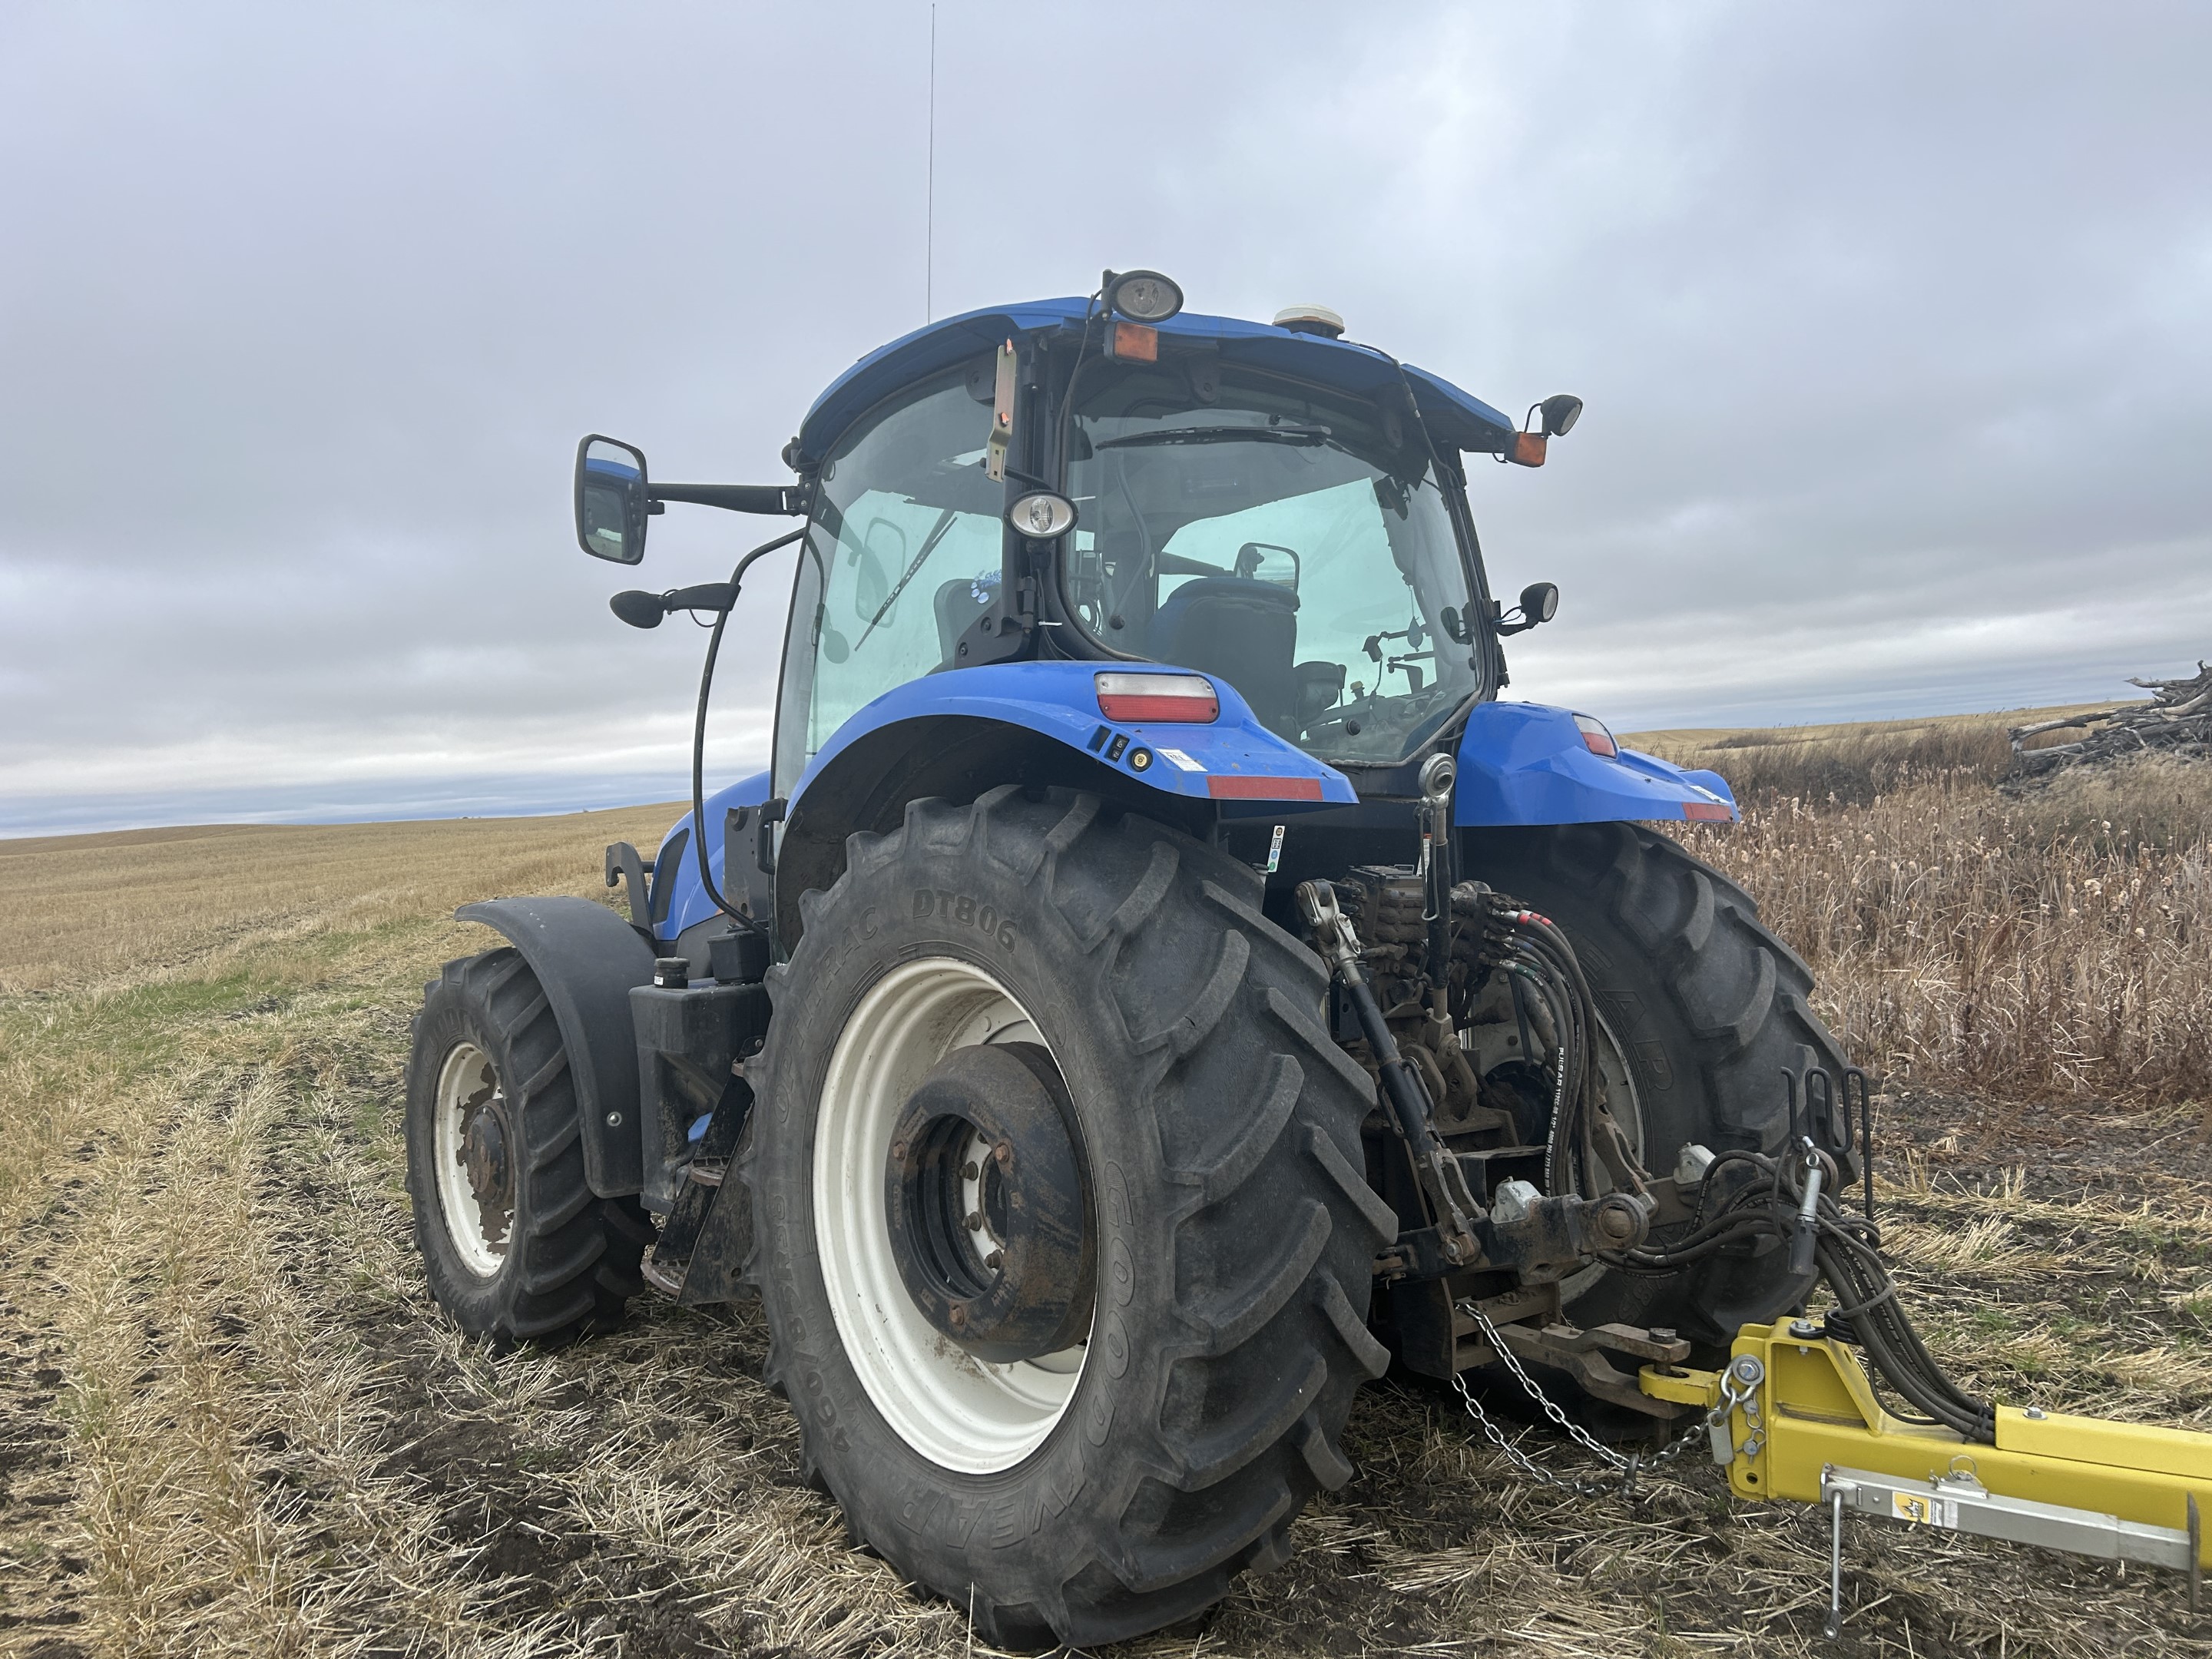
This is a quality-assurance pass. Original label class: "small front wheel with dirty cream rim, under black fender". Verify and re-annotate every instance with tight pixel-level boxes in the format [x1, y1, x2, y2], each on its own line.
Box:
[407, 949, 653, 1347]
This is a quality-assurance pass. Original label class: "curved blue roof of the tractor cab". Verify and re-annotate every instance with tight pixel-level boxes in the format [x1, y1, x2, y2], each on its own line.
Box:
[796, 299, 1513, 467]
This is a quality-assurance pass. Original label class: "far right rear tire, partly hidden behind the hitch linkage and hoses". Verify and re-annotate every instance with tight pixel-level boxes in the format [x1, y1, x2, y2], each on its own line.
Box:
[1466, 823, 1849, 1345]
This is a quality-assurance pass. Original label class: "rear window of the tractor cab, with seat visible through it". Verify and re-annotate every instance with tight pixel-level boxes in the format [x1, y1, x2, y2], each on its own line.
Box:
[1064, 363, 1480, 761]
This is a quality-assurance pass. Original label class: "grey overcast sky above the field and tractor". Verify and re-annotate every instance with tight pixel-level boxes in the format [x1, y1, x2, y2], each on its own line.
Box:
[0, 0, 2212, 834]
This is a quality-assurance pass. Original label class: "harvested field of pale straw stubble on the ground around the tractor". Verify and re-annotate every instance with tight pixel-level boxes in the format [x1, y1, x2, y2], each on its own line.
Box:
[0, 783, 2212, 1659]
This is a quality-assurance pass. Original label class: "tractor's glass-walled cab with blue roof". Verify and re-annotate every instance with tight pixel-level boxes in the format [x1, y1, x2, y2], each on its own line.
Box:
[774, 279, 1579, 794]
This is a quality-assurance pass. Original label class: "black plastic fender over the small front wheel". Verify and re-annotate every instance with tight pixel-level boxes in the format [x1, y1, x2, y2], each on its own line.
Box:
[453, 898, 653, 1199]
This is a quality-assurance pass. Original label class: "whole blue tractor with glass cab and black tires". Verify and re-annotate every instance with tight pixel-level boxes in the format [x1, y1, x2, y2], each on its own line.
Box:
[407, 272, 1852, 1646]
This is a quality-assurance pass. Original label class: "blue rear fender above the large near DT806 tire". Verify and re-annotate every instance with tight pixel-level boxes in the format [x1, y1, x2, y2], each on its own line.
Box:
[777, 661, 1358, 949]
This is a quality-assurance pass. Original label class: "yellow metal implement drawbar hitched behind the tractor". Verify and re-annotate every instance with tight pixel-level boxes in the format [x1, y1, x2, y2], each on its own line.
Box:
[1639, 1318, 2212, 1634]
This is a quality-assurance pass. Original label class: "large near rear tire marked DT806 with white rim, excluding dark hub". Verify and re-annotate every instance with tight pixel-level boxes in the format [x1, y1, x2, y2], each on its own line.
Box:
[747, 787, 1393, 1646]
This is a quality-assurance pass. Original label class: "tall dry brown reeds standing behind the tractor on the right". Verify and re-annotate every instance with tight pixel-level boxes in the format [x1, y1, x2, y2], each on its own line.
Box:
[1637, 737, 2212, 1106]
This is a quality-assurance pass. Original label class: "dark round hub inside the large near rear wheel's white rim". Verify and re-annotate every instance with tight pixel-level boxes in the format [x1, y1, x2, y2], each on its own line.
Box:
[885, 1041, 1095, 1365]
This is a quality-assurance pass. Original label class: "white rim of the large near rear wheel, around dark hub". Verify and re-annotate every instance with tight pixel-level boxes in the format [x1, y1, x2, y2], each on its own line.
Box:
[814, 955, 1086, 1475]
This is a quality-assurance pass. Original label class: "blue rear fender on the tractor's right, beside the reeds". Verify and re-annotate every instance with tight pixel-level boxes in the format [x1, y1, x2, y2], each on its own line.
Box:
[1453, 704, 1739, 827]
